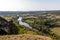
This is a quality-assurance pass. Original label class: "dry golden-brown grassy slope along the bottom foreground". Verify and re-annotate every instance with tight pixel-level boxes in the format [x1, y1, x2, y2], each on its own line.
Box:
[0, 34, 52, 40]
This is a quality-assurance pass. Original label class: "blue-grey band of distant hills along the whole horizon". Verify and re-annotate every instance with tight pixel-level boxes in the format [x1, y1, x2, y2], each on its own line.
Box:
[0, 10, 60, 15]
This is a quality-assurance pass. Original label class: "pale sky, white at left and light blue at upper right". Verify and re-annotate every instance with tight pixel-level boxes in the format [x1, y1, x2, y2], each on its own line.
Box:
[0, 0, 60, 11]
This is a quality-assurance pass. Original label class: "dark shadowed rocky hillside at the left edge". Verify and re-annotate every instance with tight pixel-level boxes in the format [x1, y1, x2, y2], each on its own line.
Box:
[0, 17, 18, 35]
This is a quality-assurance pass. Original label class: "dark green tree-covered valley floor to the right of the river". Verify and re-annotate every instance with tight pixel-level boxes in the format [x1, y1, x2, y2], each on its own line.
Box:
[23, 17, 59, 40]
